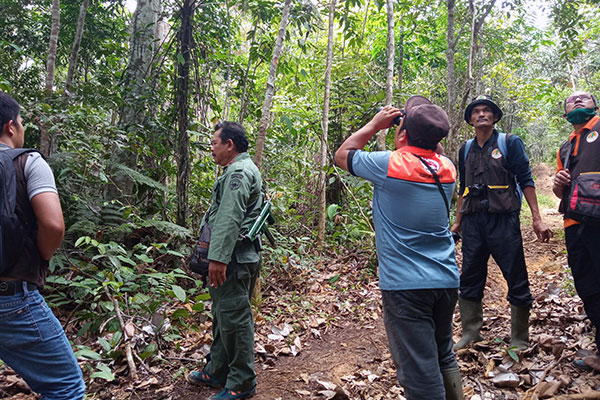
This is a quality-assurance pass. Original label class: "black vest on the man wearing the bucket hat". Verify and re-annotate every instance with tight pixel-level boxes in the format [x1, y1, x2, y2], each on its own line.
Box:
[461, 133, 521, 215]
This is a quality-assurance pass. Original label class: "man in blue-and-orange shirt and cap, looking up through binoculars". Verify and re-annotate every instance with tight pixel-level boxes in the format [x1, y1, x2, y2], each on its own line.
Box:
[335, 96, 463, 400]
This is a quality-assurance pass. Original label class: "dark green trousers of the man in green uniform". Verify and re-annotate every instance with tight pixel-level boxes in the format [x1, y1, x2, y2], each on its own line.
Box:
[205, 258, 260, 391]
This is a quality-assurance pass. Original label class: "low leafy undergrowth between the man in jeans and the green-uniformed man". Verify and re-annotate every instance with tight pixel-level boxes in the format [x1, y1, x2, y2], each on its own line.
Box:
[46, 236, 208, 381]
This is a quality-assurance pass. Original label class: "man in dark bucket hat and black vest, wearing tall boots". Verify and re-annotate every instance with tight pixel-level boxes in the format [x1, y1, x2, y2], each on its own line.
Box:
[451, 95, 552, 350]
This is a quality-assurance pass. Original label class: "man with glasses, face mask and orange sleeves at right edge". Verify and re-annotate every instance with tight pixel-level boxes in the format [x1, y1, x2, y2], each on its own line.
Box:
[552, 91, 600, 371]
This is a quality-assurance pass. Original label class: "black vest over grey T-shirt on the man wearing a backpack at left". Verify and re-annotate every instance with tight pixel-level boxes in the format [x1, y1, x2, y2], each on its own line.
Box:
[2, 153, 48, 287]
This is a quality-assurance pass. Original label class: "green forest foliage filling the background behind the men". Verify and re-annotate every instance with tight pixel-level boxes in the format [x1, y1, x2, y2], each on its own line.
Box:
[0, 0, 600, 381]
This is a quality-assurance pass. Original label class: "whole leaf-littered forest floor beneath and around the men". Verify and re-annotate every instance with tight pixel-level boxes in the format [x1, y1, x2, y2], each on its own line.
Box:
[0, 165, 600, 400]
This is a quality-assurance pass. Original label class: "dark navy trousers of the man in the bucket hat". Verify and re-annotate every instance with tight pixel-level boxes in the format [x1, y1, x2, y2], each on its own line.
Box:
[460, 211, 533, 308]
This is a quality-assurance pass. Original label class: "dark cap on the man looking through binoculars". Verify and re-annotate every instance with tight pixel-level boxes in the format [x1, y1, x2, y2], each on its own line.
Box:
[404, 104, 450, 148]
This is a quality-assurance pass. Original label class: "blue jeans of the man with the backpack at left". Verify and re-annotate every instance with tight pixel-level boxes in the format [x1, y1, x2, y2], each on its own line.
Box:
[0, 284, 85, 400]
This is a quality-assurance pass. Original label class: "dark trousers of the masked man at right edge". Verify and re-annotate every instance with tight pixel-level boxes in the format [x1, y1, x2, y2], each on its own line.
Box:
[565, 225, 600, 352]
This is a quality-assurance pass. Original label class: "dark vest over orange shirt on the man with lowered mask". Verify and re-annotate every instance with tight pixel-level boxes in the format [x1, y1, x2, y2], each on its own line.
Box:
[558, 120, 600, 221]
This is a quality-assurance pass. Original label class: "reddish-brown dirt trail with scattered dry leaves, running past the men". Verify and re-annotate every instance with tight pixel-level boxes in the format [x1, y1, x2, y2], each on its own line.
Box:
[174, 165, 600, 400]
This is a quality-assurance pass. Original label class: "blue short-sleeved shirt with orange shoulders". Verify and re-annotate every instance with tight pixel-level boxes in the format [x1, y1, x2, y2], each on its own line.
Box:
[349, 146, 458, 290]
